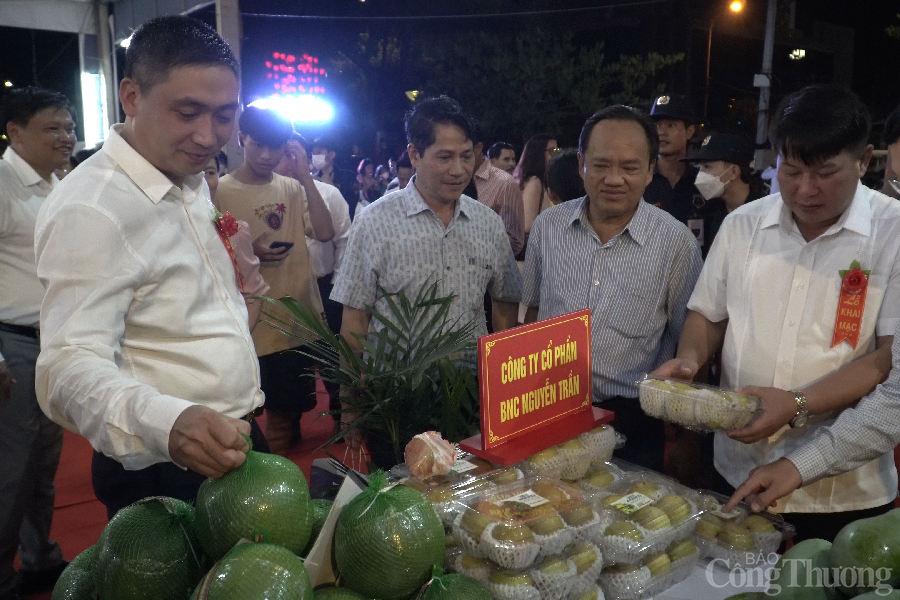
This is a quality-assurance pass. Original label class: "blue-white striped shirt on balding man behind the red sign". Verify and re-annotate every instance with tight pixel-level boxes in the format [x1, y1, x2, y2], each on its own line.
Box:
[522, 196, 703, 402]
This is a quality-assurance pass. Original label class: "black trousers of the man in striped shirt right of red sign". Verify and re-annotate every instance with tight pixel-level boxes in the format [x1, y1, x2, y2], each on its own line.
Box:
[596, 396, 666, 473]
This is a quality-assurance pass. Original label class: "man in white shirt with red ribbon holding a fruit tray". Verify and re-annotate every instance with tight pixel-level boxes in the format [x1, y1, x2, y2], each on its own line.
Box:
[656, 86, 900, 541]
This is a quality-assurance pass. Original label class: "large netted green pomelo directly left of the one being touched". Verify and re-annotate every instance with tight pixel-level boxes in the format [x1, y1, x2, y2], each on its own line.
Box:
[94, 496, 206, 600]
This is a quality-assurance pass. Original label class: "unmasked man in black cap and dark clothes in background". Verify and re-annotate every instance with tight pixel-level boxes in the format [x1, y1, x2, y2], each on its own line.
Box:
[644, 96, 705, 234]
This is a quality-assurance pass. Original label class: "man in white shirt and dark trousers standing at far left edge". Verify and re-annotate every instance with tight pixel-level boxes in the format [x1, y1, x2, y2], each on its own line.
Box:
[0, 87, 75, 600]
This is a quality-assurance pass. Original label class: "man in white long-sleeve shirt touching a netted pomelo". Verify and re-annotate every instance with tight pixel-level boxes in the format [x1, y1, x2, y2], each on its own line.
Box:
[35, 16, 265, 517]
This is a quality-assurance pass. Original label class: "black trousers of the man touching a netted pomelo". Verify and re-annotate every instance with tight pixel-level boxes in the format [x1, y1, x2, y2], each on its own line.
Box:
[91, 421, 269, 519]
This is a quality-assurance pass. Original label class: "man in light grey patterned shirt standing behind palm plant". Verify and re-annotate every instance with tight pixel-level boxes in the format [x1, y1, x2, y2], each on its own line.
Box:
[331, 96, 522, 466]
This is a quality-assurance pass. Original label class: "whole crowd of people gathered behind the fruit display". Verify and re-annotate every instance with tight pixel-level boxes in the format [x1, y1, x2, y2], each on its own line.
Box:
[0, 10, 900, 600]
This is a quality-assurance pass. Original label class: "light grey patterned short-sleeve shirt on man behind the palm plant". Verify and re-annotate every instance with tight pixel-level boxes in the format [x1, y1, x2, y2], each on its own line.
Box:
[331, 177, 522, 336]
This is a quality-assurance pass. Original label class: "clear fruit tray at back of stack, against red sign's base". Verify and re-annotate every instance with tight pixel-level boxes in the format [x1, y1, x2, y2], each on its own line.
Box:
[516, 425, 625, 481]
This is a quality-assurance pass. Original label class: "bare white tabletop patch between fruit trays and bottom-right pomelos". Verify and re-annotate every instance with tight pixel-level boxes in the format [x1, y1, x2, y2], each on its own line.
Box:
[653, 557, 774, 600]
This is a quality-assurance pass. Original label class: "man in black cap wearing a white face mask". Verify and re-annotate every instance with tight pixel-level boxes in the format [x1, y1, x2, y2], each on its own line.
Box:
[681, 133, 765, 258]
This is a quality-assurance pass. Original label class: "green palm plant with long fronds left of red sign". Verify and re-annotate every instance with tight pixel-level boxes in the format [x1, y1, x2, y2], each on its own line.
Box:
[263, 281, 480, 463]
